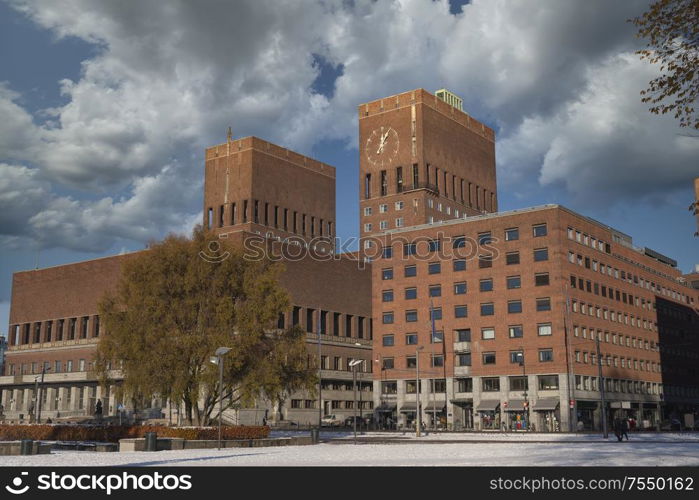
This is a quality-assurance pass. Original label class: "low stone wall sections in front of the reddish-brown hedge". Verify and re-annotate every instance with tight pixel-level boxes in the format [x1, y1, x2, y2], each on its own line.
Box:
[119, 436, 313, 451]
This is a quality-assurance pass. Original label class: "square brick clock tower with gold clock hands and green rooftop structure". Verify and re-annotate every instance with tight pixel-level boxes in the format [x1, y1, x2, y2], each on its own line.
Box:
[359, 89, 497, 256]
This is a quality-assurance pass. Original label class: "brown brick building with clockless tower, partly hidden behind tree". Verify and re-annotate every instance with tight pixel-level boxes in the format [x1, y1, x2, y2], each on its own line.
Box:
[0, 137, 373, 423]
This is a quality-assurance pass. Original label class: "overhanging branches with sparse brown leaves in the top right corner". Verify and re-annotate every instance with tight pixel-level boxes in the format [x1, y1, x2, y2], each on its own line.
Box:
[630, 0, 699, 129]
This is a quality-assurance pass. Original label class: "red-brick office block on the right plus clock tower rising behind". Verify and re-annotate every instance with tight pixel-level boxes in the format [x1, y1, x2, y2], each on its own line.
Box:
[366, 90, 699, 431]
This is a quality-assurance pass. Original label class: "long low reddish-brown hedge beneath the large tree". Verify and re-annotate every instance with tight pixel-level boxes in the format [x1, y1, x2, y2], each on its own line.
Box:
[0, 425, 269, 443]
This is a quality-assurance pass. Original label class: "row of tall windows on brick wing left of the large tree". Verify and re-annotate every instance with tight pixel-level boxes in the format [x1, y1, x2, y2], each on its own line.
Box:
[10, 315, 100, 345]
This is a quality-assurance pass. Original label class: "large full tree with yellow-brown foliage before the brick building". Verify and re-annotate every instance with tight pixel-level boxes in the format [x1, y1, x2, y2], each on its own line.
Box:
[96, 227, 316, 425]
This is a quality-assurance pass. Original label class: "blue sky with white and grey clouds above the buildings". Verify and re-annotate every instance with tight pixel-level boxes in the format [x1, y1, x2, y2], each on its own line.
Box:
[0, 0, 699, 332]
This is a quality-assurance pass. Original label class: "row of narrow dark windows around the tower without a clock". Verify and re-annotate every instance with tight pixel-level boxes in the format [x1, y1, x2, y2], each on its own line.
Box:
[206, 200, 333, 237]
